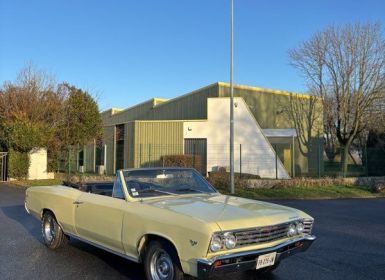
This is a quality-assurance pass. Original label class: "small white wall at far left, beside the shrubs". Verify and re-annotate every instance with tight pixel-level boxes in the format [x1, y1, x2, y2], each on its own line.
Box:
[28, 148, 54, 180]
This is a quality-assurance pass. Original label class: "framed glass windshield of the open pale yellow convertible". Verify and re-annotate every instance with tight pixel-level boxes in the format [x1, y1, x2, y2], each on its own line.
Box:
[123, 169, 217, 197]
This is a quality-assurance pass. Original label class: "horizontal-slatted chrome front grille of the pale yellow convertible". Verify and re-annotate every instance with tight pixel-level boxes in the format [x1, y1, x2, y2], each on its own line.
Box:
[234, 220, 313, 247]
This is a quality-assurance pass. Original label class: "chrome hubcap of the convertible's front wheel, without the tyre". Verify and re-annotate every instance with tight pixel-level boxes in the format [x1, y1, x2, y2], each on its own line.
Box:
[150, 250, 174, 280]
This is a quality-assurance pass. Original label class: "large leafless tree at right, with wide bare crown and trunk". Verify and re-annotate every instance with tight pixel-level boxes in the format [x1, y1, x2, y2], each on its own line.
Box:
[289, 24, 385, 174]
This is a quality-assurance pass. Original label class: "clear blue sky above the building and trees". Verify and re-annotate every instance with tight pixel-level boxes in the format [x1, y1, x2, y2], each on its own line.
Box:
[0, 0, 385, 110]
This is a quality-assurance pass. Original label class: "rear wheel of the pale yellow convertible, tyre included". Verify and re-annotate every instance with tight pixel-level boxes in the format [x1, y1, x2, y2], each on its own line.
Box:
[41, 211, 68, 249]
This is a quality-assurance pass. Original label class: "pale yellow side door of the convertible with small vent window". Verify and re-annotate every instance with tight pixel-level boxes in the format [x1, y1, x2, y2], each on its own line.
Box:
[75, 173, 127, 253]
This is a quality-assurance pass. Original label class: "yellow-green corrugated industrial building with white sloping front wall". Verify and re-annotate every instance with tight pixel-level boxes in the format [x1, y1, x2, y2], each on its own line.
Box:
[78, 82, 322, 178]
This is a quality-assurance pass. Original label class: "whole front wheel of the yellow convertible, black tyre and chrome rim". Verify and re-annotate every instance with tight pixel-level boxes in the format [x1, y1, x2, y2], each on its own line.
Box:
[144, 241, 183, 280]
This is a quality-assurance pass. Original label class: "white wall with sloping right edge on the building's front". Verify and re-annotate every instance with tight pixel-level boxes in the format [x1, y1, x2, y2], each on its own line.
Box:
[183, 97, 289, 179]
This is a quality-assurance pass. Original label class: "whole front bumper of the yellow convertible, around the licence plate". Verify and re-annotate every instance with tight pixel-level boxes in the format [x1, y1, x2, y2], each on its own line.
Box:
[198, 235, 316, 279]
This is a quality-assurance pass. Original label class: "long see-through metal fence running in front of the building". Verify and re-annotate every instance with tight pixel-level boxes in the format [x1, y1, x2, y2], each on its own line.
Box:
[58, 142, 385, 179]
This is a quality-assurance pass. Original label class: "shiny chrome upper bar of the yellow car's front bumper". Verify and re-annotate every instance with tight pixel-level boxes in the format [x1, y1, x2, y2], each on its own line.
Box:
[197, 235, 317, 265]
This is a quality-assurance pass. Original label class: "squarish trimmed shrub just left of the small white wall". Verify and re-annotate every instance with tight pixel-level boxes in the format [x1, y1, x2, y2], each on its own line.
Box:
[8, 150, 29, 179]
